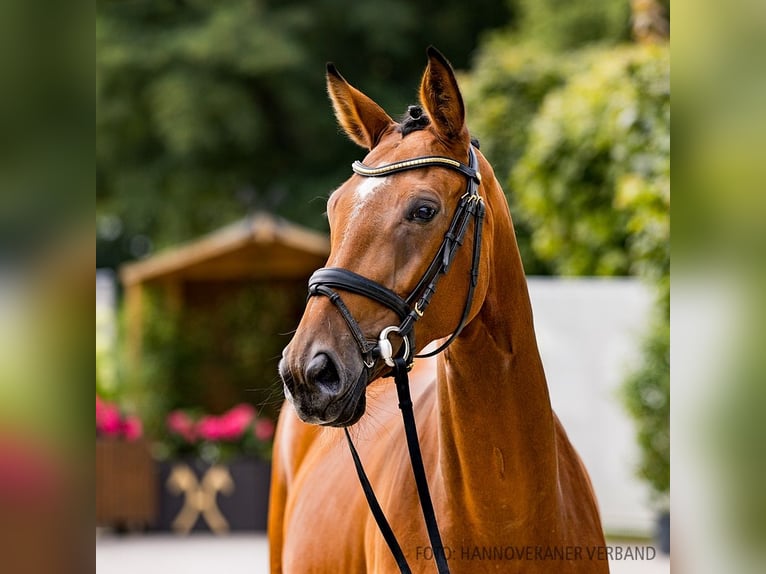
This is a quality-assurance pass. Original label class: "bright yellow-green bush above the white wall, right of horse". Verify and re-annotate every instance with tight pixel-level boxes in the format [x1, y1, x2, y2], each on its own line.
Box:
[512, 46, 670, 278]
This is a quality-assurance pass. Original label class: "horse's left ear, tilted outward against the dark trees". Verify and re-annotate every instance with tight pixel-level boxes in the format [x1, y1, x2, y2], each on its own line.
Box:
[327, 64, 394, 150]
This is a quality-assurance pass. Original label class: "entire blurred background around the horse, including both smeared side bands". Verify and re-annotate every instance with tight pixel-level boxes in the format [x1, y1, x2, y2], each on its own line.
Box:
[15, 0, 766, 573]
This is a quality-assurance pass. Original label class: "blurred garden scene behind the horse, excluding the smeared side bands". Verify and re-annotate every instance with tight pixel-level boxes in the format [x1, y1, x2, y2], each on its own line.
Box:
[95, 0, 670, 573]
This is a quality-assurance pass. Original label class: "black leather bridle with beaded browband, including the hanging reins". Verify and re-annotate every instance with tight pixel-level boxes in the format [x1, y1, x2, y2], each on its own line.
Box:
[309, 146, 485, 574]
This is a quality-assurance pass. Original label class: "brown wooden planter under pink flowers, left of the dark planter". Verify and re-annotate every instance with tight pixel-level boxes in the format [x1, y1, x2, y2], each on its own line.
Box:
[96, 438, 157, 530]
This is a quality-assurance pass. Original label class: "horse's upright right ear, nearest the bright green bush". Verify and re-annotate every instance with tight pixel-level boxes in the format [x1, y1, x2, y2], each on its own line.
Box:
[420, 46, 467, 140]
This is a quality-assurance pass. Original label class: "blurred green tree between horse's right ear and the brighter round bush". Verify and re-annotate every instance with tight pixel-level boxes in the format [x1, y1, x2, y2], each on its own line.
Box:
[463, 0, 667, 275]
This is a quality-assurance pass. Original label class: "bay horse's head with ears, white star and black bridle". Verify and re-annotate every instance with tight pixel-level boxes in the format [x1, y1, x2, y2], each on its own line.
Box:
[279, 48, 491, 426]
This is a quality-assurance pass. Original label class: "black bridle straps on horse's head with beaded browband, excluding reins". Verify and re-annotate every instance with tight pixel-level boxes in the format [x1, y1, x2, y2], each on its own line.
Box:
[309, 146, 484, 371]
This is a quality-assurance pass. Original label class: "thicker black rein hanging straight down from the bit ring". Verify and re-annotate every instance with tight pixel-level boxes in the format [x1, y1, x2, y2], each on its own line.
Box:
[394, 357, 449, 574]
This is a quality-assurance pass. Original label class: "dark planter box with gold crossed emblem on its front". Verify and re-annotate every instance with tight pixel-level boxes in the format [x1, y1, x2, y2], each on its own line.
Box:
[156, 458, 271, 534]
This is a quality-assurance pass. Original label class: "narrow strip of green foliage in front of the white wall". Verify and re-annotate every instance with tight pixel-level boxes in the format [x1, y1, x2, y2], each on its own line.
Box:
[622, 288, 670, 505]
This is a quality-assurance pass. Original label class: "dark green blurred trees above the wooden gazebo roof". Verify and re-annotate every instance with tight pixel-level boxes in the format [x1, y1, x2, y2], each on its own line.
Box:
[96, 0, 513, 265]
